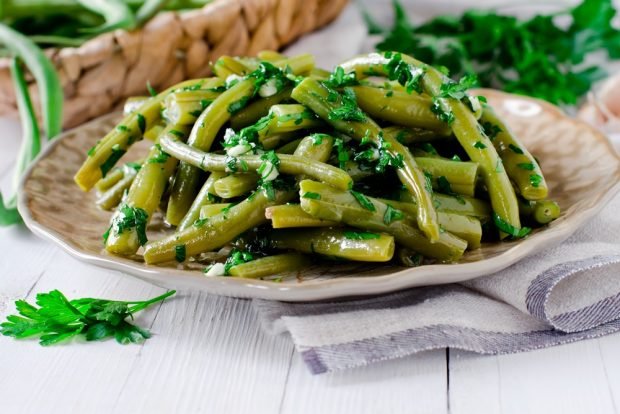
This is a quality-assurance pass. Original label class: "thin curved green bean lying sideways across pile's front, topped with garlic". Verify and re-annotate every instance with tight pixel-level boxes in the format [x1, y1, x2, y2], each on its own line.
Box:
[161, 136, 353, 189]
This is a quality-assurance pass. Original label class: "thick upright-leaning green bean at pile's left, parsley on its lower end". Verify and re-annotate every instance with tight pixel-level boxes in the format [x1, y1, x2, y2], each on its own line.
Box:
[105, 125, 188, 256]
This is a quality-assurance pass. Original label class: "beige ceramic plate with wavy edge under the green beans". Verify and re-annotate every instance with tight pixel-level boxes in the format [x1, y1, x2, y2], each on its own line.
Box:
[19, 90, 620, 301]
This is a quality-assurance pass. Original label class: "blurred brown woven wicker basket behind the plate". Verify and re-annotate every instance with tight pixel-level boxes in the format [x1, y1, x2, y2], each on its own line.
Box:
[0, 0, 347, 128]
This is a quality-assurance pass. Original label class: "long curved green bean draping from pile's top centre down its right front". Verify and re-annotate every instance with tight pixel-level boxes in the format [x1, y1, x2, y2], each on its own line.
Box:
[291, 78, 439, 241]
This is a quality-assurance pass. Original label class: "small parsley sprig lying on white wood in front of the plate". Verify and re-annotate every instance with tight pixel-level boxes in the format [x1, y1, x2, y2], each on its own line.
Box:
[0, 290, 176, 346]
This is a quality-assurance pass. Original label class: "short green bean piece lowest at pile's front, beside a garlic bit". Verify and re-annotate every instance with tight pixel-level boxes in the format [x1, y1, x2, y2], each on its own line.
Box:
[229, 253, 310, 279]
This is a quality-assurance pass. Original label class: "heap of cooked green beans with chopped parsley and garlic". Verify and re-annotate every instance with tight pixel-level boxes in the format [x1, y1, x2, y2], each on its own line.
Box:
[75, 52, 560, 280]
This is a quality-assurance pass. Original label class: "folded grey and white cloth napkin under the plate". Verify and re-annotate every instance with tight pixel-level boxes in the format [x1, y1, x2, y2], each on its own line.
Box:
[254, 187, 620, 374]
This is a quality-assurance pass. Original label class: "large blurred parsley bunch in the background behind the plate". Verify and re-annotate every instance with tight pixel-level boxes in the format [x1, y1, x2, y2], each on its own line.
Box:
[366, 0, 620, 105]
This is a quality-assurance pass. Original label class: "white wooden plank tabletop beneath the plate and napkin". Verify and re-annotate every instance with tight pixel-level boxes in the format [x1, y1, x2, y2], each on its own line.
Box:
[0, 1, 620, 414]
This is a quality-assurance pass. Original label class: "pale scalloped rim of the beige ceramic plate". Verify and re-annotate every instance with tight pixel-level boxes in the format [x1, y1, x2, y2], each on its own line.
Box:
[17, 89, 620, 302]
